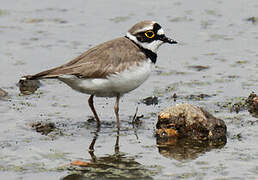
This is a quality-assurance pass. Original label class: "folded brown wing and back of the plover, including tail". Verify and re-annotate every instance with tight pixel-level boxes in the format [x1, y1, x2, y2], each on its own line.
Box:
[27, 37, 146, 79]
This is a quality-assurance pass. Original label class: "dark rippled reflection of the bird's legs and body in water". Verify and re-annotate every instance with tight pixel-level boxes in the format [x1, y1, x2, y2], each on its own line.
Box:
[62, 128, 154, 180]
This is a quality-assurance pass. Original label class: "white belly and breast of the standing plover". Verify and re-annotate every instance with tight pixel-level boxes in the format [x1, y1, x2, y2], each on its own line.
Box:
[59, 60, 153, 97]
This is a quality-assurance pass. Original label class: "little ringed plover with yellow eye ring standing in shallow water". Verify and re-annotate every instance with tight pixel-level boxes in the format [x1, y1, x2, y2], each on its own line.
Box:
[21, 21, 177, 128]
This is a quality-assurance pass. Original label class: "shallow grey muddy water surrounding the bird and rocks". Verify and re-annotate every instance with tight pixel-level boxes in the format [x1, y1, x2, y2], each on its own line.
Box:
[0, 0, 258, 180]
